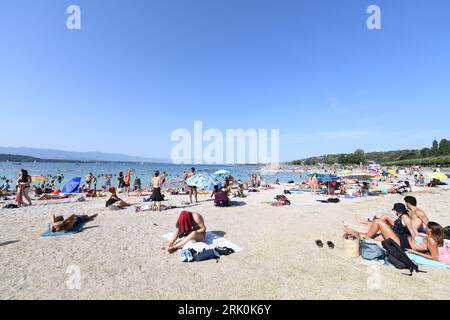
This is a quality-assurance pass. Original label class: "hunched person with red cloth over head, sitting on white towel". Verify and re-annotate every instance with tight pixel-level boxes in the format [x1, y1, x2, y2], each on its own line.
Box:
[162, 211, 206, 253]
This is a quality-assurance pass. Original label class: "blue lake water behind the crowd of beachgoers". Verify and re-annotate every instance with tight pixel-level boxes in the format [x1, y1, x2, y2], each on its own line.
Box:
[0, 162, 301, 188]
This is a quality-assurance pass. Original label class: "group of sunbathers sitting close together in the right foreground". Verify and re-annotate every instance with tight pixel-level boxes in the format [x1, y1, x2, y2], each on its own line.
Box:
[342, 196, 444, 261]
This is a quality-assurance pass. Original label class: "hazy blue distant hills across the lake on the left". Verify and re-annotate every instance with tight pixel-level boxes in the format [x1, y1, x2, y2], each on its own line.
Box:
[0, 147, 168, 163]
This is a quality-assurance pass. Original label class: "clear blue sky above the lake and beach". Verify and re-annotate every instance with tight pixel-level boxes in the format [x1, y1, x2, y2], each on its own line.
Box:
[0, 0, 450, 160]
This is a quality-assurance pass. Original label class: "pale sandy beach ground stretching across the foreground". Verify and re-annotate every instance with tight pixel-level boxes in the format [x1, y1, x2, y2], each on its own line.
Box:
[0, 182, 450, 299]
